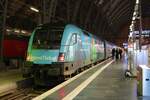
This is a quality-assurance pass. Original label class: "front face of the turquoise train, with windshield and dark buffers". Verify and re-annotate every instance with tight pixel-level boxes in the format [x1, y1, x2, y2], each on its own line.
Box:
[24, 26, 64, 85]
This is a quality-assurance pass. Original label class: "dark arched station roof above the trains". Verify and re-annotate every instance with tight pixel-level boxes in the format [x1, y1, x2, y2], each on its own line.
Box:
[3, 0, 150, 45]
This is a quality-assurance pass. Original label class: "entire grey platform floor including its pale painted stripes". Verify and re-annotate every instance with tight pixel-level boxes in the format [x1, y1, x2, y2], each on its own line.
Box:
[33, 56, 150, 100]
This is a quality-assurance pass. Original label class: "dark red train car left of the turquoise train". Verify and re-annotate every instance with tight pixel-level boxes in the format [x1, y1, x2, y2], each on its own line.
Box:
[3, 35, 29, 67]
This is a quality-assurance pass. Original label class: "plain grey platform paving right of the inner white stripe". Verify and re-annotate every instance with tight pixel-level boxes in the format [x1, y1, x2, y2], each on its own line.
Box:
[75, 61, 137, 100]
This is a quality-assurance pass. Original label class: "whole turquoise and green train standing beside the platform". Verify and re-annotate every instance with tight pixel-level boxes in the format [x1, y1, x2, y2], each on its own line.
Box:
[24, 24, 113, 85]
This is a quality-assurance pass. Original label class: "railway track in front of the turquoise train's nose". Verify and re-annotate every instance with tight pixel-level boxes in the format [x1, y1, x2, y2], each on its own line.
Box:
[0, 79, 46, 100]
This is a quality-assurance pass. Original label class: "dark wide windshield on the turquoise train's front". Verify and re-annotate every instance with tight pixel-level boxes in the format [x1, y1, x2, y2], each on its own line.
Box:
[33, 29, 63, 49]
